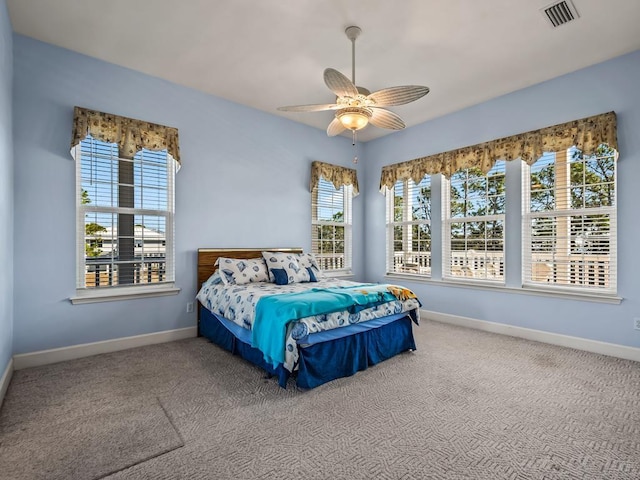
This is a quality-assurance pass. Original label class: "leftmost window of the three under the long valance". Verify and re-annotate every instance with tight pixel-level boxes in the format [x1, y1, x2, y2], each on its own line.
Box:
[386, 175, 431, 276]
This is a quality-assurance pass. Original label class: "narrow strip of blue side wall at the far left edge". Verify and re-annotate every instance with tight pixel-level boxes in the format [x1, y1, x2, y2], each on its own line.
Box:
[0, 0, 13, 377]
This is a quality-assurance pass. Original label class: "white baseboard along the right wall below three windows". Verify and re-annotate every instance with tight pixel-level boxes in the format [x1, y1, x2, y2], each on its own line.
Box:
[420, 310, 640, 362]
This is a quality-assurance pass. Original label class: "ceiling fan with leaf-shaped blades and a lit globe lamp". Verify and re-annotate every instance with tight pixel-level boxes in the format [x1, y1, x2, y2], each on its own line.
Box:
[278, 26, 429, 139]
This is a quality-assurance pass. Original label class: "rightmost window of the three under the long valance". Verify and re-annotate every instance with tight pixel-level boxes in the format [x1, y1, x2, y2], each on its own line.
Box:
[522, 145, 616, 294]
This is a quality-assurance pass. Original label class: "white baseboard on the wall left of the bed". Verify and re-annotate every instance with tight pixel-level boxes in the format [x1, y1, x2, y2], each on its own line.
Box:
[13, 327, 197, 370]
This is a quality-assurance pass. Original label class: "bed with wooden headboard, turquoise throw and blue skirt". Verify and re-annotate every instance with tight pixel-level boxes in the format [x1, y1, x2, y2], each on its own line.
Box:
[197, 248, 421, 389]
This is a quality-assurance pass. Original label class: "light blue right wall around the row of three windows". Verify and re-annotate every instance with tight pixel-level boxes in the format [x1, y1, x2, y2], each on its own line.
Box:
[362, 51, 640, 347]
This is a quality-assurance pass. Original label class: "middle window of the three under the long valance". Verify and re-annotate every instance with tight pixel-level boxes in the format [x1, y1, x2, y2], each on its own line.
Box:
[443, 160, 506, 284]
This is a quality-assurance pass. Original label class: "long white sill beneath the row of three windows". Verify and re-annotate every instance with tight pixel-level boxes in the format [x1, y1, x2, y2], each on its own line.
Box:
[385, 273, 623, 305]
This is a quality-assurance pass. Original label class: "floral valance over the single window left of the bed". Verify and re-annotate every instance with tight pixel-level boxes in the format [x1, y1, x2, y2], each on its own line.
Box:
[71, 107, 180, 164]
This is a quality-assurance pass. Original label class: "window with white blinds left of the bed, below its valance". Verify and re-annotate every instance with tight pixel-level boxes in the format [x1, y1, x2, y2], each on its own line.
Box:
[73, 136, 175, 291]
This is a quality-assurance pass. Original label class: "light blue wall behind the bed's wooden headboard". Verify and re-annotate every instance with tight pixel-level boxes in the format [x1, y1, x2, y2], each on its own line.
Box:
[11, 35, 363, 354]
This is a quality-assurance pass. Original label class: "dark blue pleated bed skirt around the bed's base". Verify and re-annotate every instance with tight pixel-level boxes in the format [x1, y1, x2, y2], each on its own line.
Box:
[198, 305, 416, 388]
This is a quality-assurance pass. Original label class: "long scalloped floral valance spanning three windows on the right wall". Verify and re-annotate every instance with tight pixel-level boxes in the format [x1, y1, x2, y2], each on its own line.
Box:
[380, 112, 618, 193]
